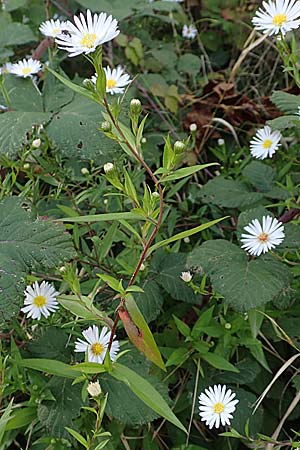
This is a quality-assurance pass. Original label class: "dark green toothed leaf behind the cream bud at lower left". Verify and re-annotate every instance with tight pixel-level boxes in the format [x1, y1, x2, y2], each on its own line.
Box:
[38, 377, 83, 438]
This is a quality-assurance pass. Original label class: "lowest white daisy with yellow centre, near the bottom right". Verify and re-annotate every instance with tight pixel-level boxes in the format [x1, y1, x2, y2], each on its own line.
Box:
[199, 384, 239, 429]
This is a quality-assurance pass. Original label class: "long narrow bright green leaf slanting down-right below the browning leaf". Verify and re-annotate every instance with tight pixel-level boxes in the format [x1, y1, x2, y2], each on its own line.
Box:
[111, 363, 186, 433]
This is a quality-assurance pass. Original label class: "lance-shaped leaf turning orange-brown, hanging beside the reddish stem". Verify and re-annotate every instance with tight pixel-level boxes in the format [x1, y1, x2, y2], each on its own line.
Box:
[119, 294, 166, 370]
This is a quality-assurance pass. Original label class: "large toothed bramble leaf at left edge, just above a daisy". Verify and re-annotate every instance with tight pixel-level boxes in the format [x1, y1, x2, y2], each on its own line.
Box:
[0, 197, 74, 323]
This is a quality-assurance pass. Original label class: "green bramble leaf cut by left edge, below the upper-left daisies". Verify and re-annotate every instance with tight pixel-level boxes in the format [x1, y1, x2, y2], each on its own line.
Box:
[0, 111, 51, 157]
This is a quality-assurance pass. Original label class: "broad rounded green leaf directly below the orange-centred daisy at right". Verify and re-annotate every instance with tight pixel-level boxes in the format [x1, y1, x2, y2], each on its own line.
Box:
[188, 239, 290, 312]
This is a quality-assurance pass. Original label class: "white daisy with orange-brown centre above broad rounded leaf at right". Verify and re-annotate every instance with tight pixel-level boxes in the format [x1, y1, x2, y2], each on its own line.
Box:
[241, 216, 285, 256]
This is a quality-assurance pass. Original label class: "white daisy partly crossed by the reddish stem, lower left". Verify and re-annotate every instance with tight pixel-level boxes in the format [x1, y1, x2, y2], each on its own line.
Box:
[75, 325, 120, 364]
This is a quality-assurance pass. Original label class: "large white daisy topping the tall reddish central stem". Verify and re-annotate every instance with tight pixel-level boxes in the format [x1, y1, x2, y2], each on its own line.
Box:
[55, 9, 120, 56]
